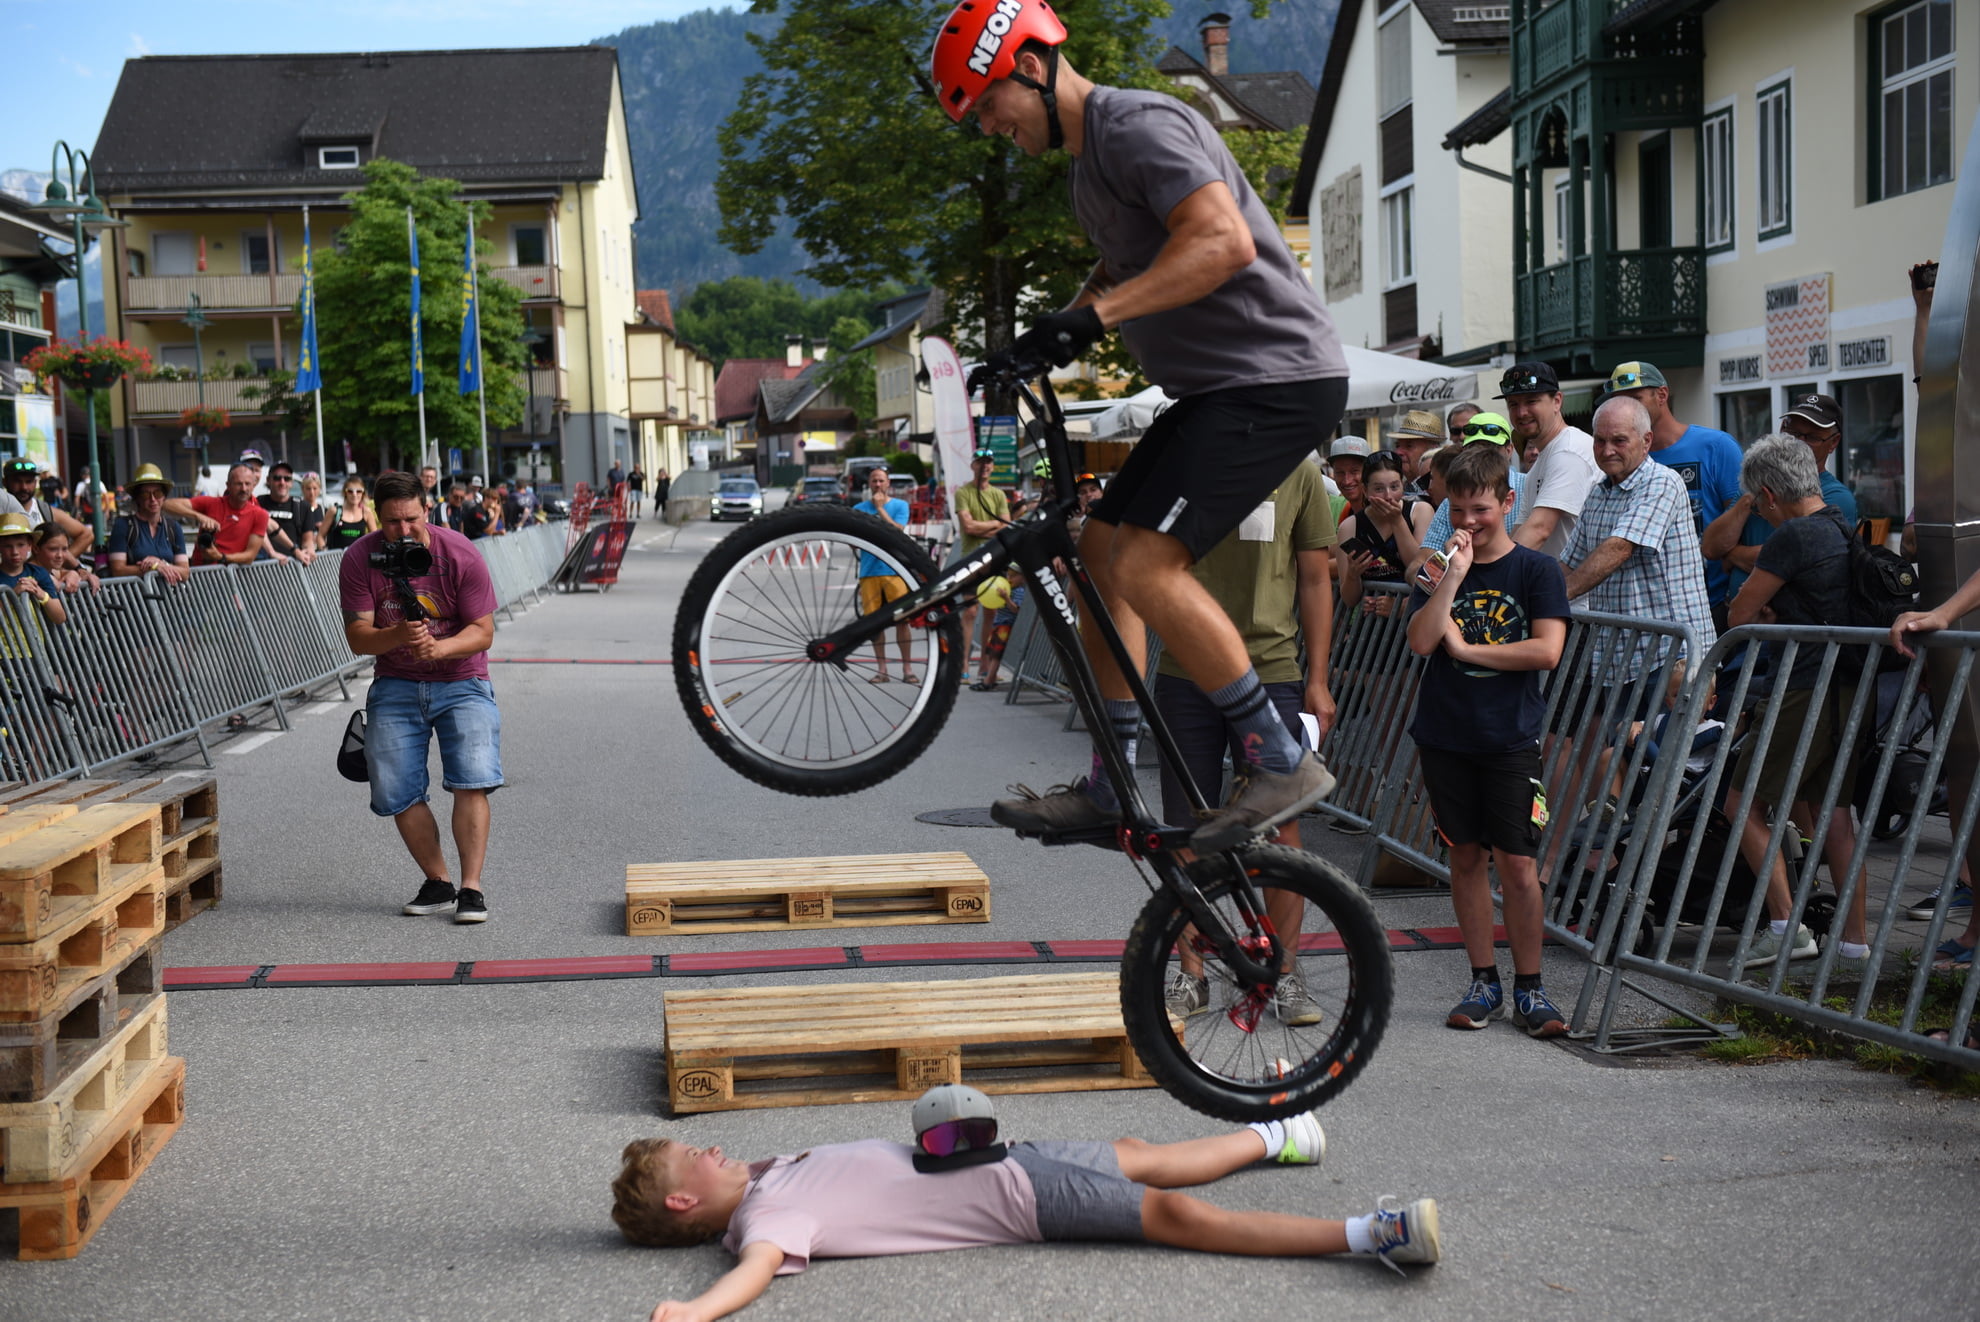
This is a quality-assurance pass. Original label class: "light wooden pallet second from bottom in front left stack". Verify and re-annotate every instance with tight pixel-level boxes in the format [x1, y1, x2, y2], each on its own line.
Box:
[0, 995, 166, 1183]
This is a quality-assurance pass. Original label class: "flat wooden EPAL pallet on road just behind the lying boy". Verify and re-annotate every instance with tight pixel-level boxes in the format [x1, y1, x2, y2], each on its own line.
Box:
[663, 974, 1152, 1114]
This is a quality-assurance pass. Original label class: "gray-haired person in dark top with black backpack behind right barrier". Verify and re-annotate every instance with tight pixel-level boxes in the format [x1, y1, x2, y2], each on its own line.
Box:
[1727, 433, 1869, 969]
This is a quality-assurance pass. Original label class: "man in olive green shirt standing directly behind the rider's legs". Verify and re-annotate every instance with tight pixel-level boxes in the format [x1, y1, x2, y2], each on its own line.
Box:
[1154, 461, 1337, 1027]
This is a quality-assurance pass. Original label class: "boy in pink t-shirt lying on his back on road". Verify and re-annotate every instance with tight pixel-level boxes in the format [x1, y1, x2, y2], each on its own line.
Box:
[612, 1114, 1439, 1322]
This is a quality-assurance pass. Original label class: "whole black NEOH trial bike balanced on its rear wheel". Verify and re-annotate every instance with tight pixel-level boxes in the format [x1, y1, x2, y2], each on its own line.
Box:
[673, 364, 1394, 1120]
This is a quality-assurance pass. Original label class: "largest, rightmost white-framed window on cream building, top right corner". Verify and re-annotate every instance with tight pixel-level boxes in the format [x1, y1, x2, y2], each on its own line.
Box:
[1871, 0, 1952, 198]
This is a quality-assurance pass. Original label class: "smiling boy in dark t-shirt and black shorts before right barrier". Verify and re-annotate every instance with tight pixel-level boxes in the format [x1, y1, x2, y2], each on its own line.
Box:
[1410, 445, 1568, 1037]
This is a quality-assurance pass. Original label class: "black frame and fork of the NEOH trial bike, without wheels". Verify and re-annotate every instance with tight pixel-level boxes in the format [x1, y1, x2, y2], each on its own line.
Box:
[806, 380, 1283, 988]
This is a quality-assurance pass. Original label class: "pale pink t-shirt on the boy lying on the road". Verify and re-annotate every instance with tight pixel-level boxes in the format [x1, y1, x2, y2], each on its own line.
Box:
[723, 1138, 1043, 1276]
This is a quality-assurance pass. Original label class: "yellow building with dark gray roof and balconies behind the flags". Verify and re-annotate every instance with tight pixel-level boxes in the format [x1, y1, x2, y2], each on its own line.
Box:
[93, 46, 640, 492]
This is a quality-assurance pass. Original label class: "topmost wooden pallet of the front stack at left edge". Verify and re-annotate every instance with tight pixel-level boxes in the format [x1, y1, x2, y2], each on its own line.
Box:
[0, 803, 160, 945]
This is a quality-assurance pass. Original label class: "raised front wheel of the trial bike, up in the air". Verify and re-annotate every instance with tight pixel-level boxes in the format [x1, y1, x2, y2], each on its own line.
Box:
[673, 507, 962, 794]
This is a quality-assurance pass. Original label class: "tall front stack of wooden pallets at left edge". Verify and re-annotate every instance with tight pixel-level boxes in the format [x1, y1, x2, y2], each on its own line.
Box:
[0, 782, 189, 1259]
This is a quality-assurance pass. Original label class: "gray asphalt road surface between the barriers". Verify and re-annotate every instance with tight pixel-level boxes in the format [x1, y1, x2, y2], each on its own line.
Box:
[0, 520, 1980, 1322]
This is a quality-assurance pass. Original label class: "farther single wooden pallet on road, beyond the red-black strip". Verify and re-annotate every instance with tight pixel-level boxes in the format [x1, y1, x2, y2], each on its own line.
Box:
[626, 853, 990, 936]
